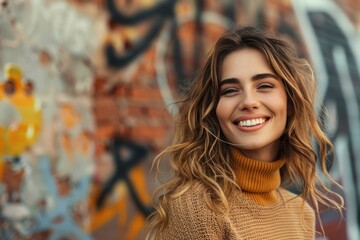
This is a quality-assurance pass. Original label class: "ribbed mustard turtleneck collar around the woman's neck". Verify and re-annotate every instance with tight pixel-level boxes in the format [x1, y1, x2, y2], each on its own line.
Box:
[231, 147, 285, 205]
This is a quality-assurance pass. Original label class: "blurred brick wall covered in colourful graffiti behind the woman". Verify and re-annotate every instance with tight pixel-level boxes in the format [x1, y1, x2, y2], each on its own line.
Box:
[0, 0, 360, 240]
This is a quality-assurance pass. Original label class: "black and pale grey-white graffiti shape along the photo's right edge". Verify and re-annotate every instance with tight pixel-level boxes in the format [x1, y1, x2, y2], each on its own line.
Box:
[293, 1, 360, 239]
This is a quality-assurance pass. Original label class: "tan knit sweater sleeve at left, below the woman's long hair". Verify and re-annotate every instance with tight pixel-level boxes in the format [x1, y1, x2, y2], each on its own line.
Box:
[159, 185, 224, 240]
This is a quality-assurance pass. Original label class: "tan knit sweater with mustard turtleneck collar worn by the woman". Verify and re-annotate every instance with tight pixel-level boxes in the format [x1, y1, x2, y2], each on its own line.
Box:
[158, 149, 315, 240]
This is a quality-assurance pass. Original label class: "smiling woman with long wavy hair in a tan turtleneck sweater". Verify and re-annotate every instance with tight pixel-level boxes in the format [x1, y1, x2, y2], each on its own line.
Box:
[147, 27, 343, 240]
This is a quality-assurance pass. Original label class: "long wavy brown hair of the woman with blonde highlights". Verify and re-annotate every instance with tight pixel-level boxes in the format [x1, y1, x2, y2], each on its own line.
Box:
[147, 27, 343, 238]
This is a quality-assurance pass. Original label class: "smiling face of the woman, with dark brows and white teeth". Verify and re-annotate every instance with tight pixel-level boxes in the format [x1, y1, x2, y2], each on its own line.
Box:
[216, 48, 287, 161]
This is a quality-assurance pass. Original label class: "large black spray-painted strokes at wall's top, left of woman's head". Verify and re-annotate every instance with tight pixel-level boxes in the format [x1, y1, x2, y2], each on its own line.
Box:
[105, 0, 235, 91]
